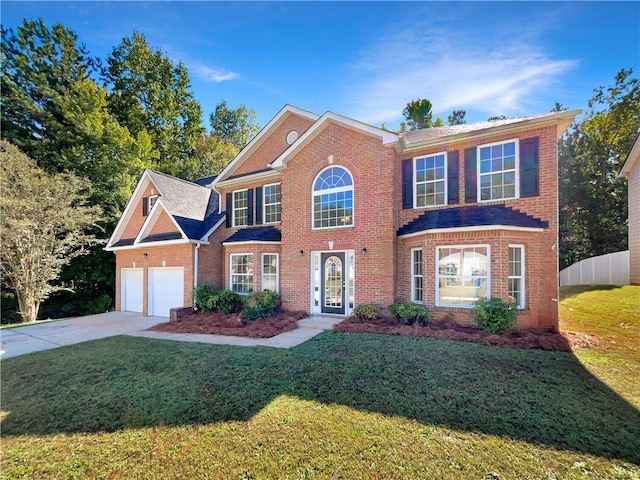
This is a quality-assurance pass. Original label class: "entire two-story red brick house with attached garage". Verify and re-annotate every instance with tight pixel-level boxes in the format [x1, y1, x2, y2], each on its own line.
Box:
[107, 106, 579, 329]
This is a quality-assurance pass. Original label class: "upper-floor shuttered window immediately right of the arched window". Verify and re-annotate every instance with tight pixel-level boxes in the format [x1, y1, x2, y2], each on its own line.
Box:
[413, 152, 447, 208]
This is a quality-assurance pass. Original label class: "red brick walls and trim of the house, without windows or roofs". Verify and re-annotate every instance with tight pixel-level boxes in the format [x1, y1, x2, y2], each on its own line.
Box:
[107, 105, 566, 329]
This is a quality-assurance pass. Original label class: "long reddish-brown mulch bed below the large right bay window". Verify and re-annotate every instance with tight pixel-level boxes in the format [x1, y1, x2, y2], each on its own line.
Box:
[333, 317, 598, 352]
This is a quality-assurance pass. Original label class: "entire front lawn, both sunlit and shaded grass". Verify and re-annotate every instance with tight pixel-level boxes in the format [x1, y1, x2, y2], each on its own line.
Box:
[1, 287, 640, 480]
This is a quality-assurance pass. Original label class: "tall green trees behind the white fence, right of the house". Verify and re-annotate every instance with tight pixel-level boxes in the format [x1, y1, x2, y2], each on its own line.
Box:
[559, 69, 640, 268]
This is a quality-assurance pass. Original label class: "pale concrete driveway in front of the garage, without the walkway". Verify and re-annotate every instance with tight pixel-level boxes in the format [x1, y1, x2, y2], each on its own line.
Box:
[0, 312, 169, 359]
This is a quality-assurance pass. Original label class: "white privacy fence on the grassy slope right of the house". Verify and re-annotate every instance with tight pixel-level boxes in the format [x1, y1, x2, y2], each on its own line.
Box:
[560, 250, 629, 287]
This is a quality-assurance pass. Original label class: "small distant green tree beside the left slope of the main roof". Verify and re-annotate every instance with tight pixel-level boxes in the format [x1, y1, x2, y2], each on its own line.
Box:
[209, 100, 260, 148]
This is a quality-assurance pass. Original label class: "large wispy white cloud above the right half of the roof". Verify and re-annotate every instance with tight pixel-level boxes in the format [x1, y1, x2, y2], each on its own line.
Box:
[350, 16, 577, 124]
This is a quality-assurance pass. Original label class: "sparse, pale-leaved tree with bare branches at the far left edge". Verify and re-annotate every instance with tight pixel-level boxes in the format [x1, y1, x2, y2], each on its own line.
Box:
[0, 141, 100, 322]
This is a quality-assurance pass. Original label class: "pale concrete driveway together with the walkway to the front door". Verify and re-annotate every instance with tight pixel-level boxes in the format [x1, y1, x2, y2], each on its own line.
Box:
[0, 312, 342, 359]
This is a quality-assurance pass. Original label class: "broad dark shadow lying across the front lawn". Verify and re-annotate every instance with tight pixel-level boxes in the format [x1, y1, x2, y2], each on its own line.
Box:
[2, 332, 640, 464]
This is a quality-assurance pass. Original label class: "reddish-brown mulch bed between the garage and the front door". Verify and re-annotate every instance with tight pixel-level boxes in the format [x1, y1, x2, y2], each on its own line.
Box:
[149, 311, 308, 338]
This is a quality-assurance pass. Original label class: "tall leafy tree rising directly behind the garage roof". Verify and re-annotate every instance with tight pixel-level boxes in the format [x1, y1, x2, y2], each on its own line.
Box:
[103, 32, 204, 178]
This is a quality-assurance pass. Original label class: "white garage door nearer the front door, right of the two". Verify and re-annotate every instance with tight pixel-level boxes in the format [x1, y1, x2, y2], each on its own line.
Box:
[149, 267, 184, 317]
